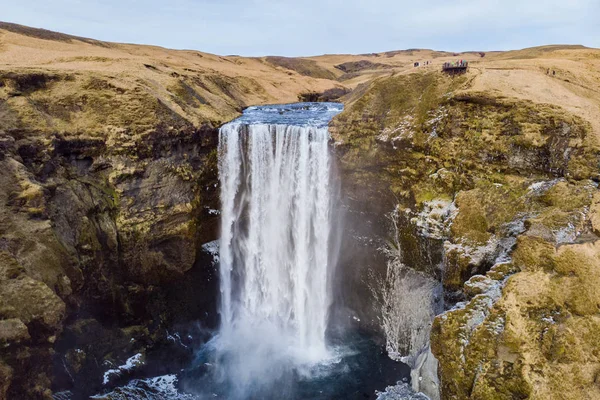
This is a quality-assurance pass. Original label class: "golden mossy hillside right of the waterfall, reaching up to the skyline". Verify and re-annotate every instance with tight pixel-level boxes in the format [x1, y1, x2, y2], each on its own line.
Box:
[332, 46, 600, 400]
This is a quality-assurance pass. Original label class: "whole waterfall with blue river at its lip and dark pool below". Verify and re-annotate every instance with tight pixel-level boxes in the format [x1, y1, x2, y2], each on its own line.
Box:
[85, 103, 410, 400]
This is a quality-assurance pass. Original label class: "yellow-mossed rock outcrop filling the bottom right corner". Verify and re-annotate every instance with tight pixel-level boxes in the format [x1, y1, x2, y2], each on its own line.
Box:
[432, 236, 600, 399]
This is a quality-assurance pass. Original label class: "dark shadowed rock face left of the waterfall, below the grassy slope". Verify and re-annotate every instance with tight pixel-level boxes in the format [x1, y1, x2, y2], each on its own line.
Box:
[0, 71, 218, 398]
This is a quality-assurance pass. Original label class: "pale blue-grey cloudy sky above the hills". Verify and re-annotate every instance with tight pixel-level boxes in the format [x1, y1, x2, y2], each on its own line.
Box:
[0, 0, 600, 56]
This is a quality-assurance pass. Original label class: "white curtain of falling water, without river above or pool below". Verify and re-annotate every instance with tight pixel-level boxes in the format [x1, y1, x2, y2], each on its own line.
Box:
[218, 111, 335, 391]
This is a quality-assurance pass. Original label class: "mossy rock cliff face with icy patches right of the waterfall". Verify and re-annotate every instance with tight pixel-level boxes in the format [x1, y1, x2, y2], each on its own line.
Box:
[333, 64, 600, 399]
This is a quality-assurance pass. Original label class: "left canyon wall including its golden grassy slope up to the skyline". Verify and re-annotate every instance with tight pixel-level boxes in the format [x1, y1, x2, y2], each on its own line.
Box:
[0, 23, 346, 399]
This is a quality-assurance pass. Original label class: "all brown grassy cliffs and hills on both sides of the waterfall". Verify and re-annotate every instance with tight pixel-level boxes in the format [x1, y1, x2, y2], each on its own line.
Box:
[0, 23, 600, 399]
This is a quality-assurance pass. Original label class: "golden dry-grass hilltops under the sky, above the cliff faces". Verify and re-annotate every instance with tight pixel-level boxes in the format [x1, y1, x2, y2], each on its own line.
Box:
[0, 23, 600, 138]
